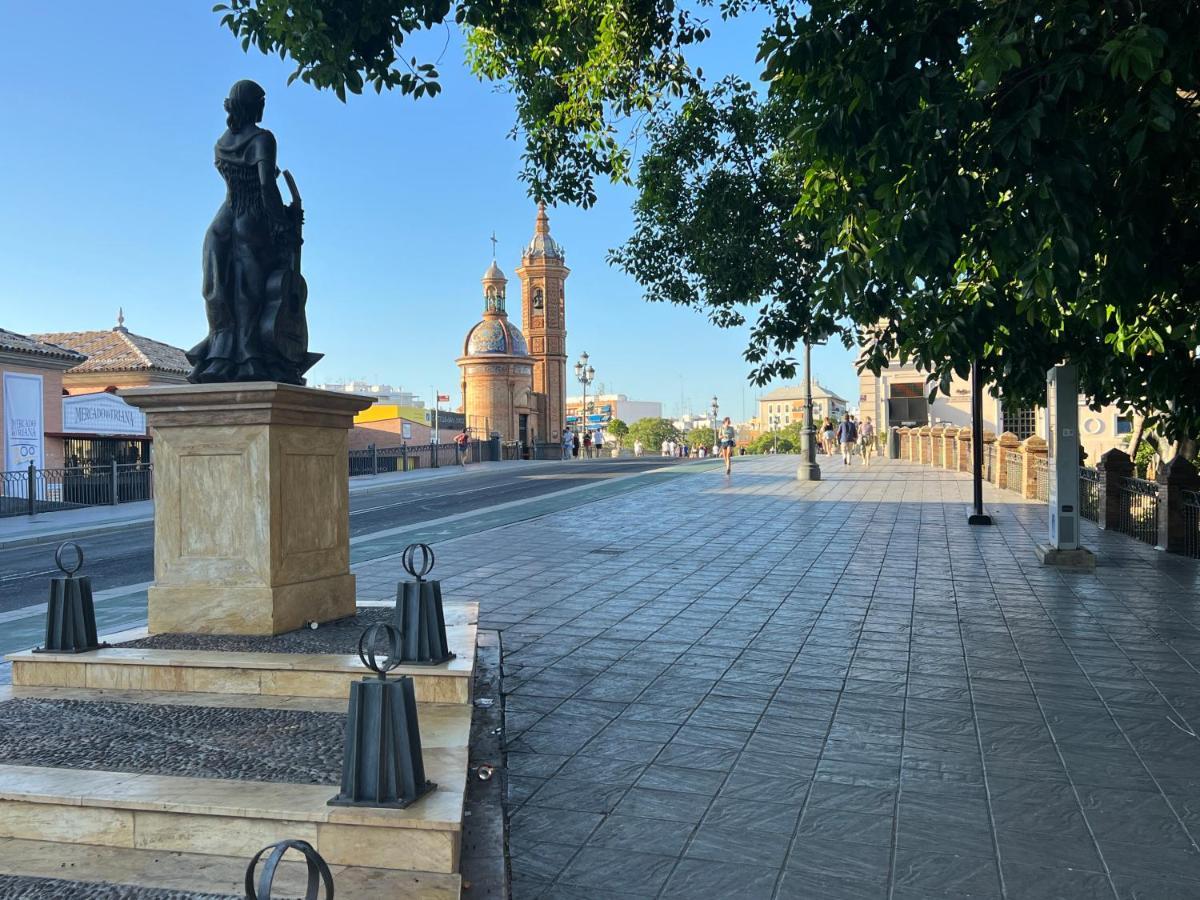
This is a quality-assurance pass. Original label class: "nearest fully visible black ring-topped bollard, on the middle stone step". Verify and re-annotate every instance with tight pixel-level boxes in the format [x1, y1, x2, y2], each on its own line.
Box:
[329, 622, 437, 809]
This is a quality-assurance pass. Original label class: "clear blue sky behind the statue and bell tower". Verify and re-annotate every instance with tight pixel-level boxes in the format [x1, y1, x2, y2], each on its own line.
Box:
[0, 2, 858, 419]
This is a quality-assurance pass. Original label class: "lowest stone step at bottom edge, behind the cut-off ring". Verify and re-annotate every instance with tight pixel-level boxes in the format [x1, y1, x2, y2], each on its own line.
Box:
[0, 838, 461, 900]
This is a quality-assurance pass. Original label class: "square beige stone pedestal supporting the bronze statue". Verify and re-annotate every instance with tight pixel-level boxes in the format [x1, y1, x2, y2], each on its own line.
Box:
[120, 382, 371, 635]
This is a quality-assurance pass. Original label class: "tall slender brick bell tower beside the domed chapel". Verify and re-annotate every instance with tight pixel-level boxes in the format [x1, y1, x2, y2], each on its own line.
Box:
[517, 202, 571, 443]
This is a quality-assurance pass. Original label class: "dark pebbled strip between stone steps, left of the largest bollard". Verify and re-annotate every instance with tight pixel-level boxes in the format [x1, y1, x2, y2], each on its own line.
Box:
[0, 698, 346, 787]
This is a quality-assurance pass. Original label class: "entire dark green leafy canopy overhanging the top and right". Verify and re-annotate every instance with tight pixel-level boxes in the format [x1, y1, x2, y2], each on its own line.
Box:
[217, 0, 1200, 437]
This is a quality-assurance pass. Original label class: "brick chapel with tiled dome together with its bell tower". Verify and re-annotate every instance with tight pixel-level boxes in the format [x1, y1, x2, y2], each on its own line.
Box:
[457, 203, 570, 446]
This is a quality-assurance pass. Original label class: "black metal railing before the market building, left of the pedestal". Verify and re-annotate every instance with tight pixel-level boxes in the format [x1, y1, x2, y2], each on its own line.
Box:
[0, 462, 154, 516]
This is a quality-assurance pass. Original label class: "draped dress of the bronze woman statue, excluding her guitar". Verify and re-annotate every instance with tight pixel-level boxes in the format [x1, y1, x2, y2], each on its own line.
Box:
[187, 126, 280, 382]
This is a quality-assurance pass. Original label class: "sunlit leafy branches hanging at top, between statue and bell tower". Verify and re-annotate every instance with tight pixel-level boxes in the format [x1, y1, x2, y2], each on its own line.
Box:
[214, 0, 708, 205]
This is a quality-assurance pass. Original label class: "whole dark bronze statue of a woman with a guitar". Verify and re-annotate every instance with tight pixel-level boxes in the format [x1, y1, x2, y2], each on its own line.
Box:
[187, 80, 320, 384]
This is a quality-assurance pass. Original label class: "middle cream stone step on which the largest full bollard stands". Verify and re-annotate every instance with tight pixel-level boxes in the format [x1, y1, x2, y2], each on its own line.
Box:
[0, 749, 467, 875]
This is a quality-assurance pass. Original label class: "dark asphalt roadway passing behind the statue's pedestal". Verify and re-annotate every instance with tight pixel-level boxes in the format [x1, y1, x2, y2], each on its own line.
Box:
[0, 457, 679, 612]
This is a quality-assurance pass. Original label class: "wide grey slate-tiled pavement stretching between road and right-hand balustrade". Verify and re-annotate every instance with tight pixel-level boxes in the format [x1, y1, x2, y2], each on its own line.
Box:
[420, 457, 1200, 900]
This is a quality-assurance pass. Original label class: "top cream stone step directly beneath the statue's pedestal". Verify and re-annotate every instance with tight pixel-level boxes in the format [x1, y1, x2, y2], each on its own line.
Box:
[5, 604, 478, 704]
